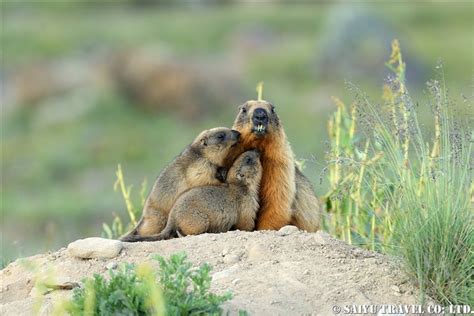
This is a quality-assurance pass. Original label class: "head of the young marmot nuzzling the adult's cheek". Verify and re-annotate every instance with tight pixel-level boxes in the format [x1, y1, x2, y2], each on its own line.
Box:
[191, 127, 240, 165]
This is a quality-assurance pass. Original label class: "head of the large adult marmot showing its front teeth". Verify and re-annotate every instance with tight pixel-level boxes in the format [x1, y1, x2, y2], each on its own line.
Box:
[234, 100, 280, 139]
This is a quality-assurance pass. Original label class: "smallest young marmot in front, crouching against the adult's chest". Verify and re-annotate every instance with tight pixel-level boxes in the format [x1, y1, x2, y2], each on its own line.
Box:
[131, 150, 262, 241]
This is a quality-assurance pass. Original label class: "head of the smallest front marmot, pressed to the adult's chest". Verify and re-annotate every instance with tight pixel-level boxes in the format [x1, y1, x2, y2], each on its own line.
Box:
[227, 149, 262, 186]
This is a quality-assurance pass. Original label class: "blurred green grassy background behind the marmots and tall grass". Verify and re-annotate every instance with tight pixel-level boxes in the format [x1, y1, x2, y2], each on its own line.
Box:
[0, 0, 474, 260]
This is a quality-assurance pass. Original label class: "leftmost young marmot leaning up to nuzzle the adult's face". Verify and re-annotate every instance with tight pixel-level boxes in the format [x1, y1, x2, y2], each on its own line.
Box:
[121, 127, 240, 242]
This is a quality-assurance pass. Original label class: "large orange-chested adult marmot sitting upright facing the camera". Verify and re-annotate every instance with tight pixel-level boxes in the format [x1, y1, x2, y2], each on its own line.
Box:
[226, 100, 321, 232]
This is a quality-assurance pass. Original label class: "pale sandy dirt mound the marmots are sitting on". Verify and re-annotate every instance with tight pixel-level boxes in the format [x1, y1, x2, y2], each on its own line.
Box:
[0, 227, 426, 315]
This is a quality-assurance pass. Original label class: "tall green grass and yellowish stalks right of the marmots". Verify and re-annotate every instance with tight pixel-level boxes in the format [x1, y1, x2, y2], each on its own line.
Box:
[324, 41, 474, 304]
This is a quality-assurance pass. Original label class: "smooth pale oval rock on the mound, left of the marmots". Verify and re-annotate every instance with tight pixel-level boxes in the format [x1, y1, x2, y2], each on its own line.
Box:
[67, 237, 123, 259]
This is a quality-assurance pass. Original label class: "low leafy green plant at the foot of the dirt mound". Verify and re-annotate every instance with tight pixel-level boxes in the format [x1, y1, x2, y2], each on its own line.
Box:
[65, 253, 232, 315]
